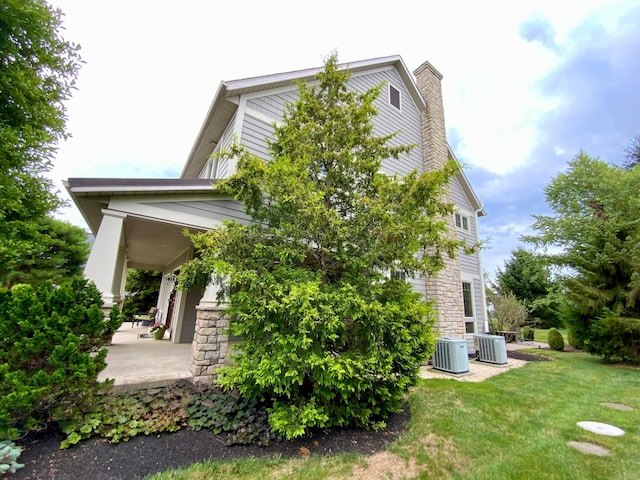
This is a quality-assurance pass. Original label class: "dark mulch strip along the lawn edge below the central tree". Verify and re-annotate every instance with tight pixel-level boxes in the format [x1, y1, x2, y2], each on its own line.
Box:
[13, 407, 409, 480]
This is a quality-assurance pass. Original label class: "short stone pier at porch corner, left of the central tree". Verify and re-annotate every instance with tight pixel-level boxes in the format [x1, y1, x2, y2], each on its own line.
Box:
[191, 305, 229, 382]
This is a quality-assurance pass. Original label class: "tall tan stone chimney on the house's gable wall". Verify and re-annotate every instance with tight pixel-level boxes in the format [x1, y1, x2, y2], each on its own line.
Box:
[413, 62, 465, 338]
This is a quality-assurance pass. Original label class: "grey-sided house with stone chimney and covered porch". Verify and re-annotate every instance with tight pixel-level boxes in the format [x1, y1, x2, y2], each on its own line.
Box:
[65, 56, 487, 378]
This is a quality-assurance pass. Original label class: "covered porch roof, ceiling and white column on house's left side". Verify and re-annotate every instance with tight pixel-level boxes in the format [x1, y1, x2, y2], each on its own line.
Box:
[65, 178, 249, 345]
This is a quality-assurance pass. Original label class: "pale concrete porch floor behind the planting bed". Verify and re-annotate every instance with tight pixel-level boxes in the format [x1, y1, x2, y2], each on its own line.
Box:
[98, 322, 193, 390]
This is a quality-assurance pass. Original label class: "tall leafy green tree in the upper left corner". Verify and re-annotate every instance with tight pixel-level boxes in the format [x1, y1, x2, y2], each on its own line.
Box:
[0, 0, 81, 274]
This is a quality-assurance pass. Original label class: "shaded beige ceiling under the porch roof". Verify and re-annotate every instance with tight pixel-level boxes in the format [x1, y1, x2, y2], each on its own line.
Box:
[124, 217, 202, 270]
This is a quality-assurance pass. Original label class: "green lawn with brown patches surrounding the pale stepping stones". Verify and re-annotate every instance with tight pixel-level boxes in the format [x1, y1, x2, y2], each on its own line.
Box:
[150, 351, 640, 480]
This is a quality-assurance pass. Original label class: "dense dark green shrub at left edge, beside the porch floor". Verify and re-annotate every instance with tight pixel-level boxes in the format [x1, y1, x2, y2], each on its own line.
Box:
[0, 278, 122, 439]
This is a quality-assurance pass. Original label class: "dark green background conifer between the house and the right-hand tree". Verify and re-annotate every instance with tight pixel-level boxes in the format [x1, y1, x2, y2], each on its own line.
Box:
[496, 247, 558, 328]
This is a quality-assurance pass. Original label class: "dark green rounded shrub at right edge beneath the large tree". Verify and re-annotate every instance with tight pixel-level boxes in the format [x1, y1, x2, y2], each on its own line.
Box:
[584, 316, 640, 363]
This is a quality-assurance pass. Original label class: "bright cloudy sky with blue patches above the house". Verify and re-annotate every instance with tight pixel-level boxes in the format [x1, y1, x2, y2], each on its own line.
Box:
[49, 0, 640, 277]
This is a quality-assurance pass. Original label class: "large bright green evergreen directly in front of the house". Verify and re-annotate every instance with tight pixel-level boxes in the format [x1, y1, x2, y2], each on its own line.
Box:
[181, 56, 462, 437]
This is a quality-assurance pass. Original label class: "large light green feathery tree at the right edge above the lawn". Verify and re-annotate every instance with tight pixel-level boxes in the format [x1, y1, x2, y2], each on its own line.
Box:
[526, 152, 640, 340]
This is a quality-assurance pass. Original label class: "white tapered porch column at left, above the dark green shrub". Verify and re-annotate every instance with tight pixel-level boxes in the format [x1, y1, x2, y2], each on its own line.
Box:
[84, 209, 126, 308]
